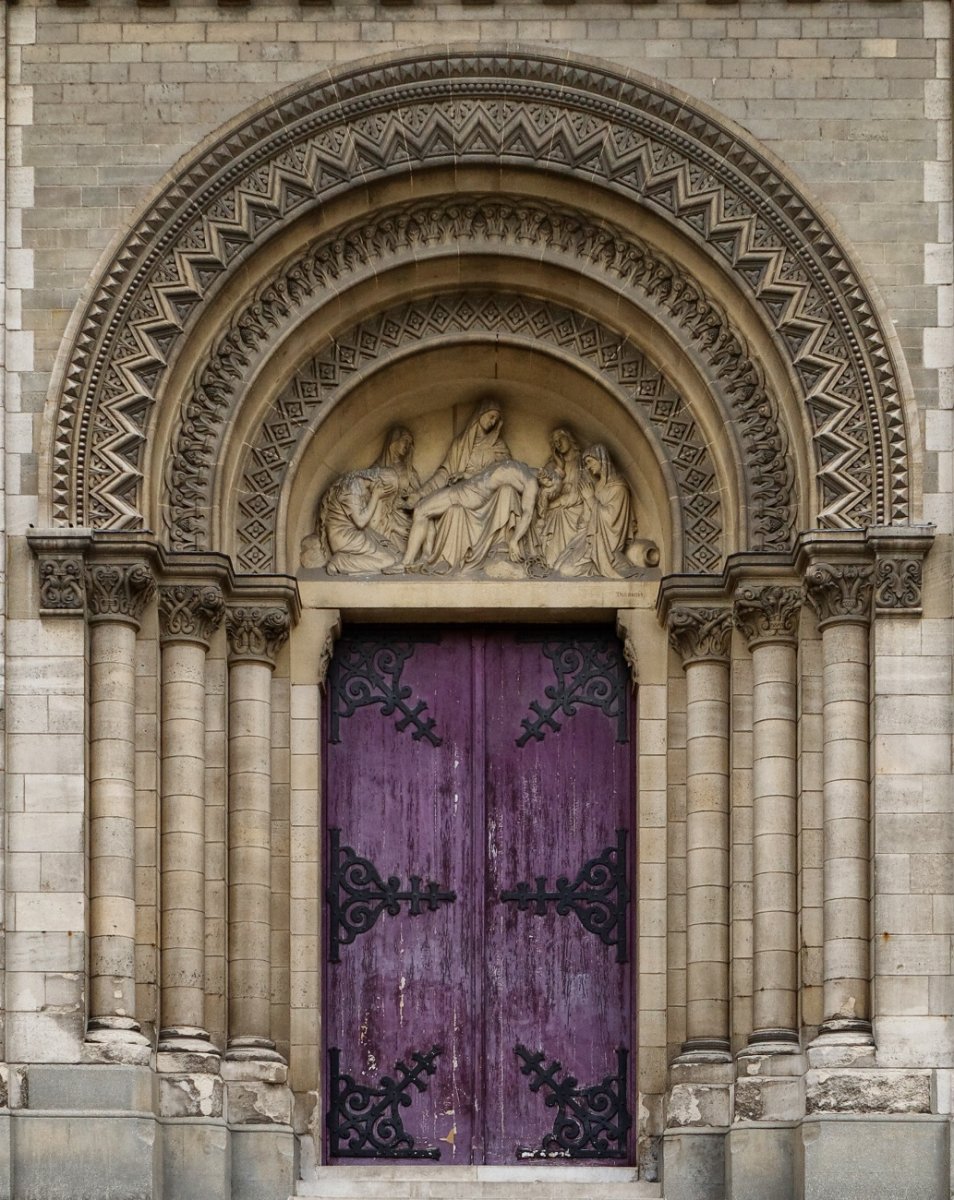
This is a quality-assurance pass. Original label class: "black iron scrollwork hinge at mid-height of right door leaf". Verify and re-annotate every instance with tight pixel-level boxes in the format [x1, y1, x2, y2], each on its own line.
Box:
[500, 829, 629, 962]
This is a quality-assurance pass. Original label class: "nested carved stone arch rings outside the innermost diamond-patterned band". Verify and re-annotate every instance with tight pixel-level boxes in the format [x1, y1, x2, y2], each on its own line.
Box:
[48, 39, 918, 559]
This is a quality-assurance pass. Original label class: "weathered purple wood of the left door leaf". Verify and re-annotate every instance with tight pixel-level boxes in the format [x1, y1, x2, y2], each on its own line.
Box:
[326, 631, 475, 1163]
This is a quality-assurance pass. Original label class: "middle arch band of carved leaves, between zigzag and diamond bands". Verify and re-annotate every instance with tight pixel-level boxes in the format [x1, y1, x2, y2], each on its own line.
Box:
[171, 197, 794, 570]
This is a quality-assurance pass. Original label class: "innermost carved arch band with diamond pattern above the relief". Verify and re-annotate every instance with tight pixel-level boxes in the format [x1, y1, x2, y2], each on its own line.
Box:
[238, 292, 724, 571]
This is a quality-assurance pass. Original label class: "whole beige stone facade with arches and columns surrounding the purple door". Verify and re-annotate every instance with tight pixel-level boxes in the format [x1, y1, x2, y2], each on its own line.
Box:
[0, 7, 954, 1200]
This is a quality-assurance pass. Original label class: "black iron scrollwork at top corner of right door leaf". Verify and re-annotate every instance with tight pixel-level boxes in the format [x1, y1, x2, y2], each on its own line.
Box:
[516, 637, 629, 746]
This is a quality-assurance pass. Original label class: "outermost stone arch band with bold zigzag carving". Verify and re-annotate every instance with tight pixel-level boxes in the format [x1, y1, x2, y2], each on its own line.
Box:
[50, 53, 911, 548]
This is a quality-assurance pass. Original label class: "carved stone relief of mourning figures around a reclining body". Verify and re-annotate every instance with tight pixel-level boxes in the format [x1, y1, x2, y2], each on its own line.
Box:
[301, 398, 659, 580]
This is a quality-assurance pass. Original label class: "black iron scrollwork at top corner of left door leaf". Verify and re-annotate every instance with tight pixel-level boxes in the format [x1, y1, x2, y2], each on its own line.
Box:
[329, 637, 443, 746]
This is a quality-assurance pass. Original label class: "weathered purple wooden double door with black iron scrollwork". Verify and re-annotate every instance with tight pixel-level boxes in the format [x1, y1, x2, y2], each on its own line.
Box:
[325, 626, 635, 1165]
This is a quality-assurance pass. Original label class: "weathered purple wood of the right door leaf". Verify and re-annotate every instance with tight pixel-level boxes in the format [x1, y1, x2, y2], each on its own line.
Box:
[484, 634, 630, 1163]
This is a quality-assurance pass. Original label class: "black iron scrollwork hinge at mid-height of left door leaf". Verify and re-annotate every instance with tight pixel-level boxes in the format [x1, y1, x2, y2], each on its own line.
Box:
[326, 829, 457, 962]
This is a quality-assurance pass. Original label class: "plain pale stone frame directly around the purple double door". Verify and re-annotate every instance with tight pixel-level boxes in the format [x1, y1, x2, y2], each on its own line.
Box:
[288, 595, 682, 1180]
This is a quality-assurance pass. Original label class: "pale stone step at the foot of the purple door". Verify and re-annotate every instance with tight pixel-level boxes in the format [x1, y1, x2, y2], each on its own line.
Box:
[293, 1165, 662, 1200]
